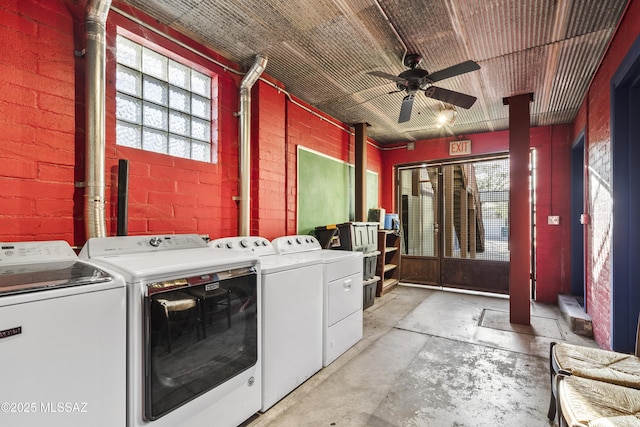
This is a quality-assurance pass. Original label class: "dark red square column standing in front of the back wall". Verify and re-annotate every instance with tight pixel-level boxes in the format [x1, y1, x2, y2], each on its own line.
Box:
[504, 93, 533, 325]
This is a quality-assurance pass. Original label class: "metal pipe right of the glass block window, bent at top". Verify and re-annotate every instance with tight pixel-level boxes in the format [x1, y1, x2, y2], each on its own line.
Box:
[238, 55, 267, 236]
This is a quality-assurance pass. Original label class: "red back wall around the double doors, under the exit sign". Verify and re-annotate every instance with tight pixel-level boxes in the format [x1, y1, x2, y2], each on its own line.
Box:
[382, 126, 571, 303]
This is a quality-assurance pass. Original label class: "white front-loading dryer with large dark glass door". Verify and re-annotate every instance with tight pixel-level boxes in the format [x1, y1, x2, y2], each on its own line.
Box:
[80, 234, 261, 427]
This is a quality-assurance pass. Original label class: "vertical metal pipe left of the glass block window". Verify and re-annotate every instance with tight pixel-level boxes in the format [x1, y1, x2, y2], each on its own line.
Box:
[84, 0, 111, 239]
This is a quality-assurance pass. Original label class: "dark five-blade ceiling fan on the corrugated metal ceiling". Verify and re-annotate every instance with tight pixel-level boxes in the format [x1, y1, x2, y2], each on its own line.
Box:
[367, 53, 480, 123]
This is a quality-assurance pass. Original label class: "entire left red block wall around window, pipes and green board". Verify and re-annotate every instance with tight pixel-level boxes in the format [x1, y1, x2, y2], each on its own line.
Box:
[0, 0, 382, 246]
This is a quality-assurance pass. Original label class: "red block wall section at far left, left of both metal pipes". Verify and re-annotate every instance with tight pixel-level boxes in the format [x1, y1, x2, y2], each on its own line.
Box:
[0, 0, 81, 243]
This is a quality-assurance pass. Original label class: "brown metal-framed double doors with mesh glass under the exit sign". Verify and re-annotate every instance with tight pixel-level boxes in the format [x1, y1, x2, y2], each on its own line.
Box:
[398, 156, 512, 293]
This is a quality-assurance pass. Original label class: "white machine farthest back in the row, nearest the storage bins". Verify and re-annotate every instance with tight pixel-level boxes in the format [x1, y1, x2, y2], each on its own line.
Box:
[272, 235, 363, 366]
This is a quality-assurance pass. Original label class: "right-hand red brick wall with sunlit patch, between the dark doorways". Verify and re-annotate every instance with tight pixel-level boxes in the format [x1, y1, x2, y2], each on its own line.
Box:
[572, 0, 640, 348]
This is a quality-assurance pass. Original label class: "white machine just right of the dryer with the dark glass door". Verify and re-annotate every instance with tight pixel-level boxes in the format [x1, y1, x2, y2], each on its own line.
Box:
[209, 237, 322, 412]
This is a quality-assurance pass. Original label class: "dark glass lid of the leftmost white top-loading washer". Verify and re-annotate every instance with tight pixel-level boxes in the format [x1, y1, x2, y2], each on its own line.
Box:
[0, 261, 113, 296]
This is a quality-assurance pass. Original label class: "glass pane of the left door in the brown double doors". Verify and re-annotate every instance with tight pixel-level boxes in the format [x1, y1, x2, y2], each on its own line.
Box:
[400, 166, 438, 256]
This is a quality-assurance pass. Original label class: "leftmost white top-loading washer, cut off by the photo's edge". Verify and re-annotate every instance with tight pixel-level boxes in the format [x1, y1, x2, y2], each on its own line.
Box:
[0, 241, 126, 427]
